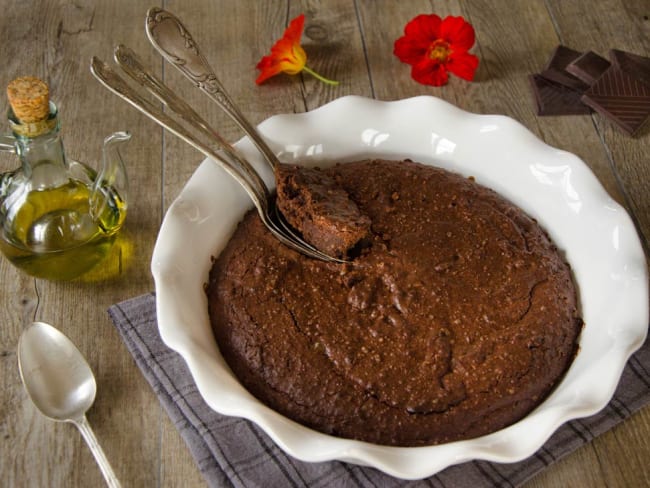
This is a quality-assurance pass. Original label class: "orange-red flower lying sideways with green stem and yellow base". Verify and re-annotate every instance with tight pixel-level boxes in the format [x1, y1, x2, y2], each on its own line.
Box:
[255, 14, 339, 85]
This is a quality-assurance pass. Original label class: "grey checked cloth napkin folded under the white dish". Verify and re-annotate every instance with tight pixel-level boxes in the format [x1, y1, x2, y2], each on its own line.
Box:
[109, 294, 650, 488]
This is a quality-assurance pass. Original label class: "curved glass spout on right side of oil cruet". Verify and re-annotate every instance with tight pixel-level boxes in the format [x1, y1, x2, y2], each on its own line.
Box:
[90, 131, 131, 227]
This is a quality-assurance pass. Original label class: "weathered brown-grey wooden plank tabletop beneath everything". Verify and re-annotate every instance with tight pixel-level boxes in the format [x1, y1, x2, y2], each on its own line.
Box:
[0, 0, 650, 488]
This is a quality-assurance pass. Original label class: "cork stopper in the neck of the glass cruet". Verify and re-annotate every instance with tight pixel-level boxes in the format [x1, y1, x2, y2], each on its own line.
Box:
[7, 76, 50, 124]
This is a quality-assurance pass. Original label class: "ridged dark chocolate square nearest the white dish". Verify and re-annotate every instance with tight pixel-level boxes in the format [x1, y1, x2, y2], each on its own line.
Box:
[582, 66, 650, 135]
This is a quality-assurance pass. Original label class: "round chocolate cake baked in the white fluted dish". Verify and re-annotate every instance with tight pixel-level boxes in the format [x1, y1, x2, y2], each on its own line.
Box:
[206, 160, 582, 446]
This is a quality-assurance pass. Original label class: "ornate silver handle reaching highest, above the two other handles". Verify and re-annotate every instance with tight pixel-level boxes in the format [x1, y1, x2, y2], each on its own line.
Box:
[146, 7, 279, 170]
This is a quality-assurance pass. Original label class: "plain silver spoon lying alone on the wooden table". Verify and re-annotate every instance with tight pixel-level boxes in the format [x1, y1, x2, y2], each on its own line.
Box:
[18, 322, 120, 488]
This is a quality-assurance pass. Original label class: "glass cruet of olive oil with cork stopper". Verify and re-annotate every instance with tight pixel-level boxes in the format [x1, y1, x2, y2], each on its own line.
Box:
[0, 77, 130, 280]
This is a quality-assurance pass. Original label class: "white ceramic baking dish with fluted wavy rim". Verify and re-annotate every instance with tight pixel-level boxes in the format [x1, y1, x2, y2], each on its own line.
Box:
[152, 96, 648, 479]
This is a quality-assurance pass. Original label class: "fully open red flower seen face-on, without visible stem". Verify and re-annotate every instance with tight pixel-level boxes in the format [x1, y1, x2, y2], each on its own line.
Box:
[393, 14, 478, 86]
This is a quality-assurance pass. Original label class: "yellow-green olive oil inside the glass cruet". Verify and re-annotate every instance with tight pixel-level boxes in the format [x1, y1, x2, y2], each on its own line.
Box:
[0, 180, 126, 280]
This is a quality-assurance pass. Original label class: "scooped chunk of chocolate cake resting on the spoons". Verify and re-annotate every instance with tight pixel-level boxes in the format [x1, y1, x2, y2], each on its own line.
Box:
[275, 164, 371, 258]
